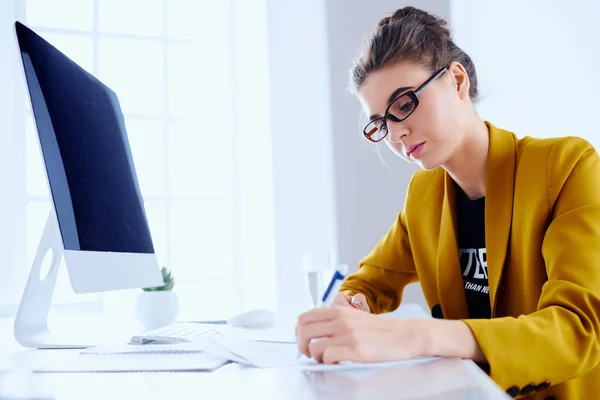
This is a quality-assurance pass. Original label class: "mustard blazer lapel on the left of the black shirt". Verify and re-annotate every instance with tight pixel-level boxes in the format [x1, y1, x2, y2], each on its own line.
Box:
[437, 172, 469, 319]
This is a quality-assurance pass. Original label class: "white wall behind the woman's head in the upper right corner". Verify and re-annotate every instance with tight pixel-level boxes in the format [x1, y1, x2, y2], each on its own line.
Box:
[451, 0, 600, 147]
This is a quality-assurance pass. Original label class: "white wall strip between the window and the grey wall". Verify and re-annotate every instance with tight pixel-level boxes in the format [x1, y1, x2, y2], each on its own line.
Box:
[267, 0, 336, 318]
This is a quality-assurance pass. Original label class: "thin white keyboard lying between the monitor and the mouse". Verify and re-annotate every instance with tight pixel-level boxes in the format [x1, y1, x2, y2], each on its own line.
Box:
[129, 322, 217, 344]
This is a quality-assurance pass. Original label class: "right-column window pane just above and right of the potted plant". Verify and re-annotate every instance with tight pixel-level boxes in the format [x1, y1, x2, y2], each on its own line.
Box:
[170, 201, 233, 279]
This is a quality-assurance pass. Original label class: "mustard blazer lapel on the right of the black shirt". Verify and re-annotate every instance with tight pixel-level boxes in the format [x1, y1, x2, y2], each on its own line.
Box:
[485, 122, 517, 317]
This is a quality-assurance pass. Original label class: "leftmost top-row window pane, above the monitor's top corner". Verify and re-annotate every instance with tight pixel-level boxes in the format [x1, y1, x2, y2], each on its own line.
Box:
[25, 0, 94, 30]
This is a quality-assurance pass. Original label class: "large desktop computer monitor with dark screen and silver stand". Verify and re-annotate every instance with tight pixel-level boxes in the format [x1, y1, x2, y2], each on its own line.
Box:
[15, 22, 163, 347]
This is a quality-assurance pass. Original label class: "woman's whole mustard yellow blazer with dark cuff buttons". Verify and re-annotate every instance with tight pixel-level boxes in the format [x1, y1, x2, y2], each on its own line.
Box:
[341, 122, 600, 399]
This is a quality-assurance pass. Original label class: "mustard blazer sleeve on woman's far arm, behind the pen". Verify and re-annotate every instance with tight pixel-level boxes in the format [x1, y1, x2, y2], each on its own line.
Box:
[340, 179, 418, 314]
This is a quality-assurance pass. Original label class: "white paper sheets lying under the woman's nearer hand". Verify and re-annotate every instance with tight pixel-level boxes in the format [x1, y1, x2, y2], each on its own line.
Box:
[210, 335, 439, 371]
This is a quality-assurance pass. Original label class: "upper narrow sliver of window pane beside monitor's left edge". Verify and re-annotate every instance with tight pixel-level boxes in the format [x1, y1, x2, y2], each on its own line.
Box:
[25, 116, 49, 197]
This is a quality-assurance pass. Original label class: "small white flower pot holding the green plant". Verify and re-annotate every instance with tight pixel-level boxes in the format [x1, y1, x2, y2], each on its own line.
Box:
[135, 290, 179, 330]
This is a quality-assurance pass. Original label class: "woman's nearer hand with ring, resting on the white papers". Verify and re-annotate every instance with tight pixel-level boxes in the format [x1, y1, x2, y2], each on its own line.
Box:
[296, 307, 427, 364]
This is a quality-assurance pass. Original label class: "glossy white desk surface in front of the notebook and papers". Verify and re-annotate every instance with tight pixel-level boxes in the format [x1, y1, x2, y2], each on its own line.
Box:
[0, 308, 510, 400]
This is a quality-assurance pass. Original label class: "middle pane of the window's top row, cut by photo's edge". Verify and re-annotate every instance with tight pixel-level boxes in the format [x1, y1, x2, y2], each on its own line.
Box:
[98, 0, 164, 36]
